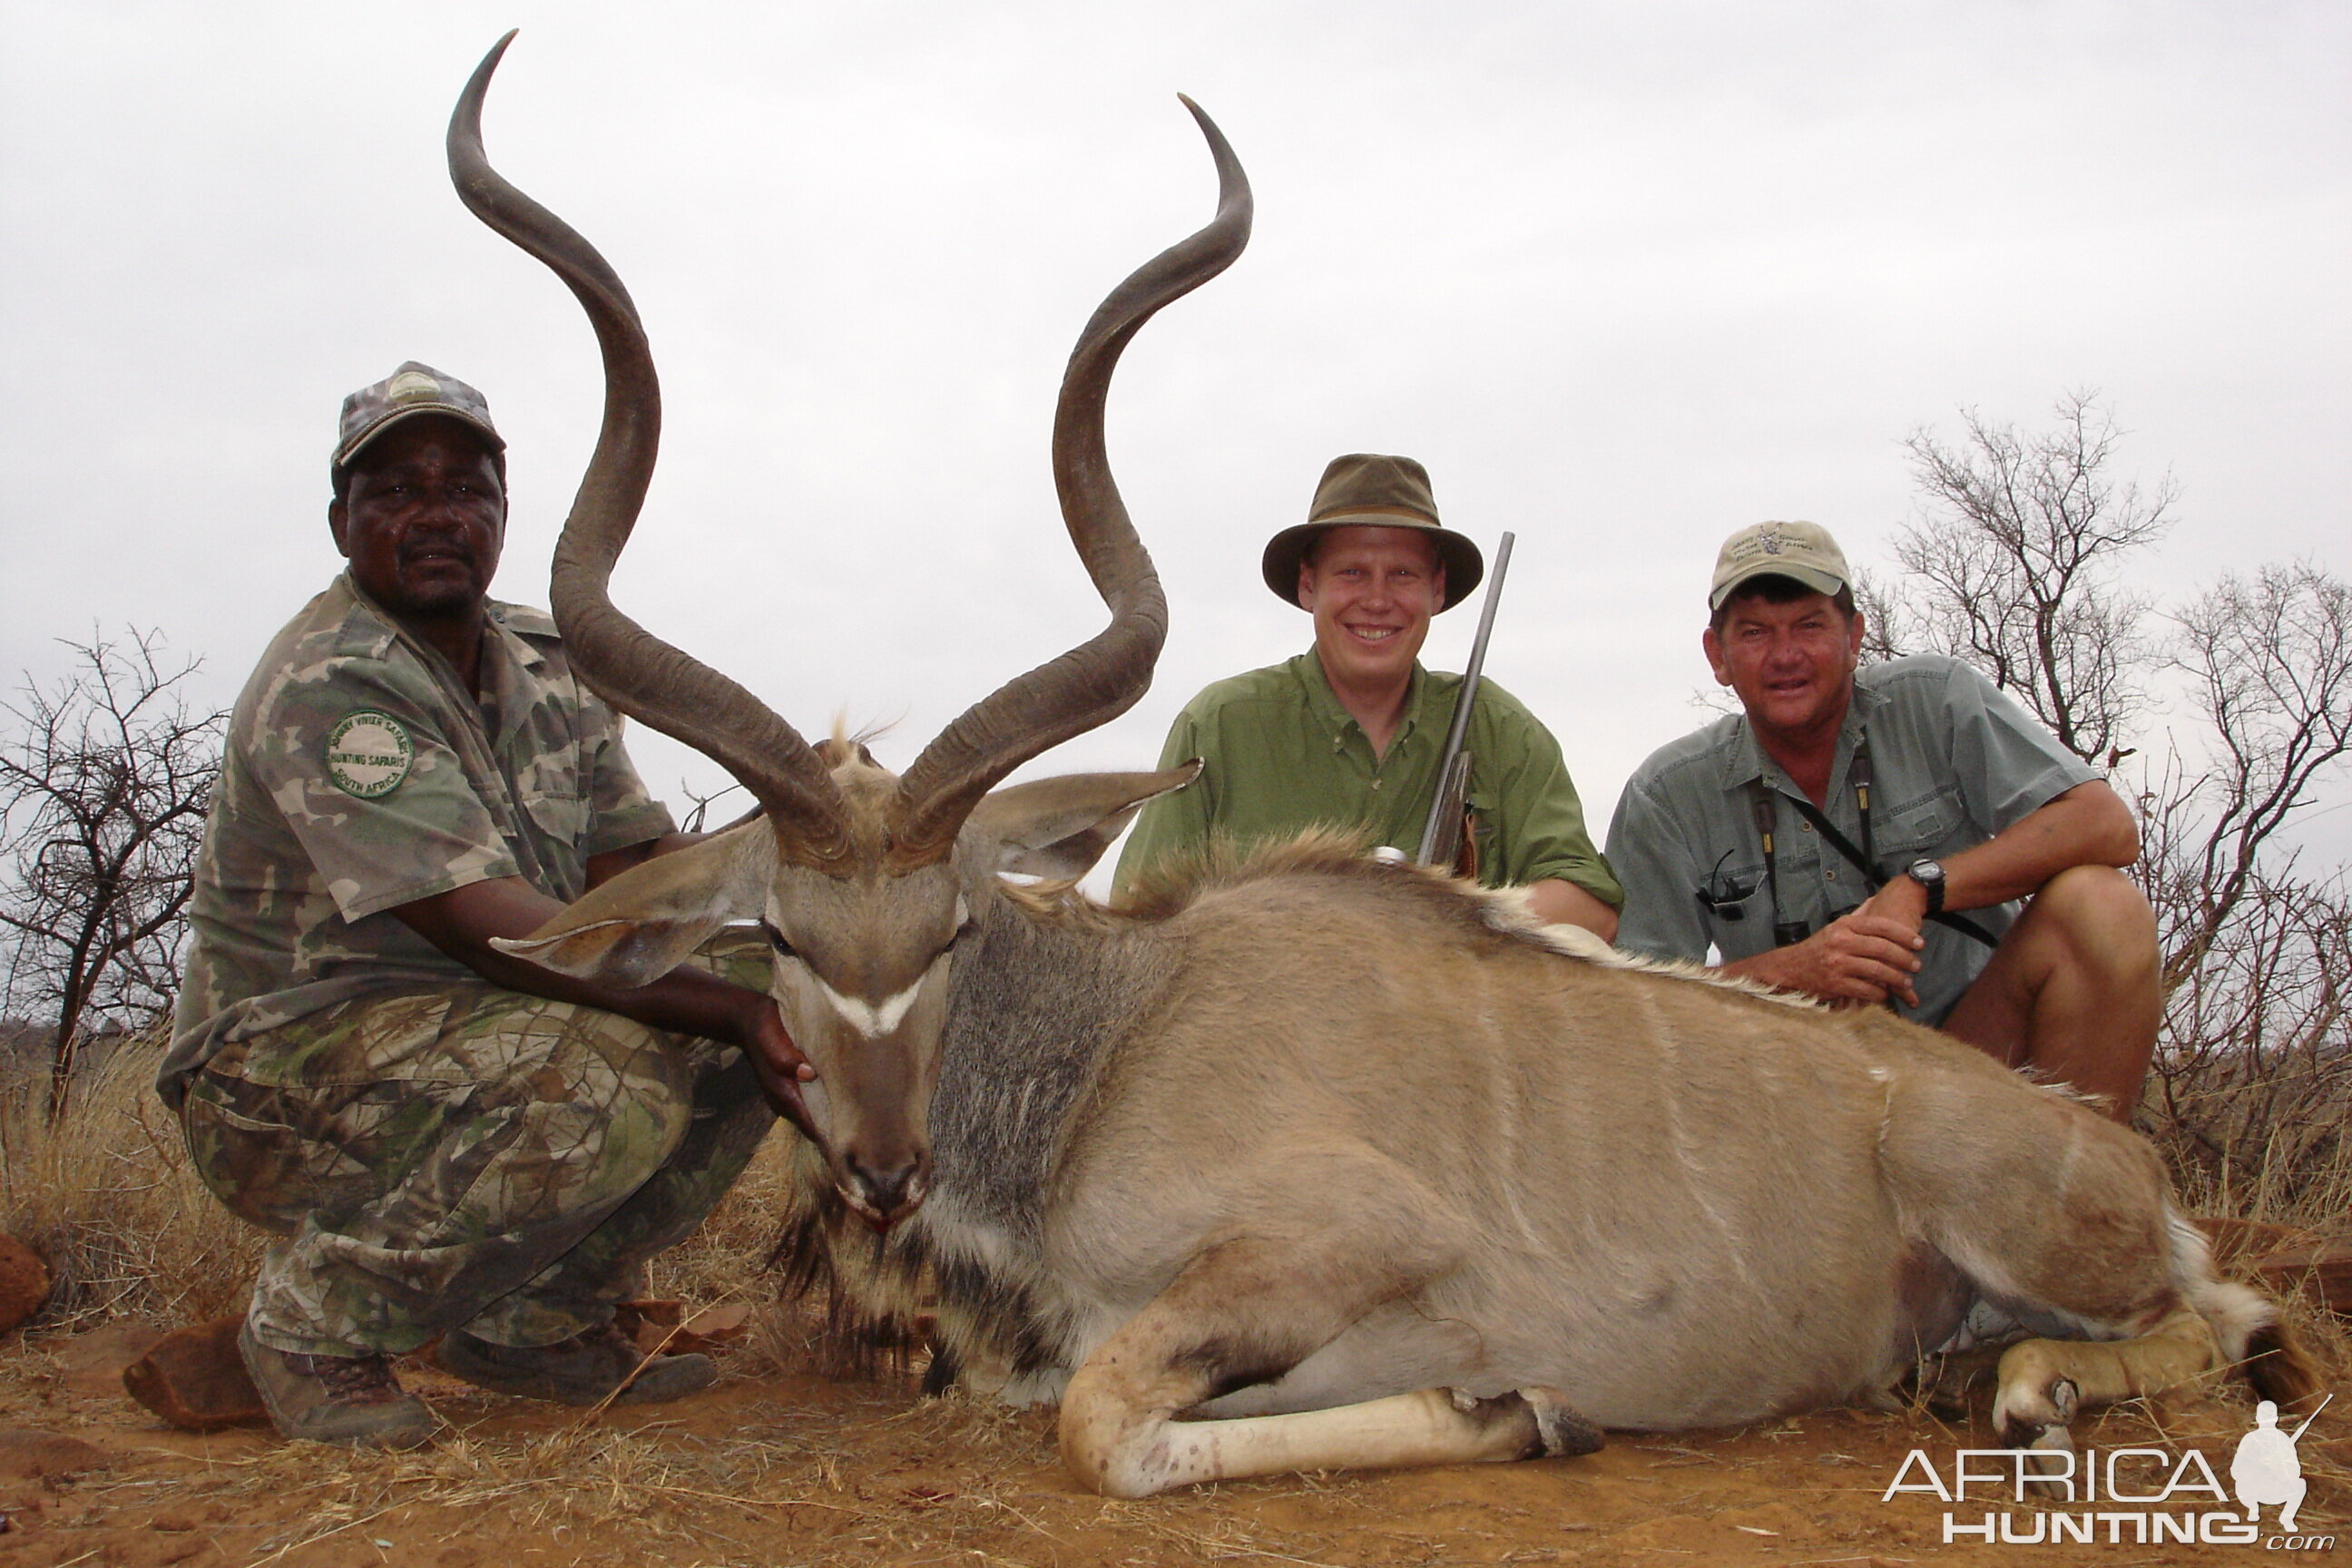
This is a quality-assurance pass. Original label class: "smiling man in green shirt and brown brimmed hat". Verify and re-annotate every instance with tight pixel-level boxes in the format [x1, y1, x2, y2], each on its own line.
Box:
[1117, 454, 1625, 938]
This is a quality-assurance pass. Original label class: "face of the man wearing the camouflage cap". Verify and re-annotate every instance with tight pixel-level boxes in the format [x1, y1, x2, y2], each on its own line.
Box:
[327, 414, 505, 621]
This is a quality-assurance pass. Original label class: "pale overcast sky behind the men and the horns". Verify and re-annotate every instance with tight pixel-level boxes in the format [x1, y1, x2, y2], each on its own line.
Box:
[0, 0, 2352, 869]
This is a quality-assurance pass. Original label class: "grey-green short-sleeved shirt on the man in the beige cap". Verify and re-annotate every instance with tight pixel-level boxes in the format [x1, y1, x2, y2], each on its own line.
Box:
[1609, 656, 2101, 1023]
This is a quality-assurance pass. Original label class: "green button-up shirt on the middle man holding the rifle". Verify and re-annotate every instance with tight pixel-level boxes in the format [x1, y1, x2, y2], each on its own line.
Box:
[1117, 649, 1625, 907]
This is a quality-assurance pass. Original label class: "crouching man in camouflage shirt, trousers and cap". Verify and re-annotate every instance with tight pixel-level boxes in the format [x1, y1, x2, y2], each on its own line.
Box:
[158, 362, 807, 1446]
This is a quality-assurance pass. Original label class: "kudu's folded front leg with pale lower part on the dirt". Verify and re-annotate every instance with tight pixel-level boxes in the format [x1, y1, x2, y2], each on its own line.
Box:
[1061, 1239, 1602, 1497]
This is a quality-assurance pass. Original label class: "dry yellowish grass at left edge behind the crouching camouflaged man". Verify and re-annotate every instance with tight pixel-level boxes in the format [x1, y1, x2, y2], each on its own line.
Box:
[0, 1037, 261, 1328]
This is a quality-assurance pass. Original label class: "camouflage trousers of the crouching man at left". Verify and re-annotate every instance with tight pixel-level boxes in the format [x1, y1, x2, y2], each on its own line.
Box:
[181, 934, 774, 1357]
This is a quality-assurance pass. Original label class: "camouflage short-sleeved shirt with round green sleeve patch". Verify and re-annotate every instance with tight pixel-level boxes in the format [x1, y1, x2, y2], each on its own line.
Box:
[158, 576, 671, 1107]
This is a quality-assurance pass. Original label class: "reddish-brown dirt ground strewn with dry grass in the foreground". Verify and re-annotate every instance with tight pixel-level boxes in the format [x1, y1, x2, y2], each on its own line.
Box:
[0, 1326, 2352, 1568]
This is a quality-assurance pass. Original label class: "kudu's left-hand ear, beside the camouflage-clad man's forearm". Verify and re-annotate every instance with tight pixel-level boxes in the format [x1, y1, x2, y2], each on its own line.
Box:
[489, 816, 776, 990]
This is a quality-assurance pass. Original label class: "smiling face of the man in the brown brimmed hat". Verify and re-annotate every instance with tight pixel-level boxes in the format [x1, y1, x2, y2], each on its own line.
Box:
[1298, 524, 1446, 686]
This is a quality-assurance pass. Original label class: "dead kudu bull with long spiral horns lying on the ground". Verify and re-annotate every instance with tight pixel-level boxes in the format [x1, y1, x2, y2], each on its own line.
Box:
[449, 44, 2309, 1497]
